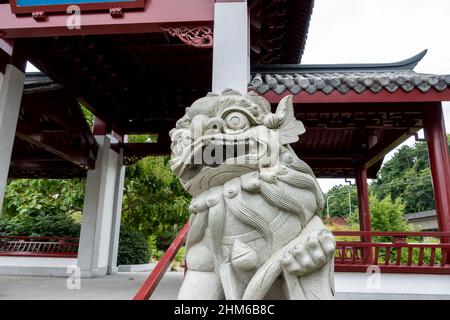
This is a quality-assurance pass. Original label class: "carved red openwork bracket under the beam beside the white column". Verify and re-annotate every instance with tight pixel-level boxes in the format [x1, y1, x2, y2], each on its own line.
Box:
[161, 26, 214, 49]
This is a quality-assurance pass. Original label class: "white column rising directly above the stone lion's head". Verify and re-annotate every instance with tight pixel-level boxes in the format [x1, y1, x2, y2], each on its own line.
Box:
[212, 1, 250, 94]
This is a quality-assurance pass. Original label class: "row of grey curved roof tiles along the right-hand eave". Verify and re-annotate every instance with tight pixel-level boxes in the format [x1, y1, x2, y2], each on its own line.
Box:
[250, 70, 450, 94]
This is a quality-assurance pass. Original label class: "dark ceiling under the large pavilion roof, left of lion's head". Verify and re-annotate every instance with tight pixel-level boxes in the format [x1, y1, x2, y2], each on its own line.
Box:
[26, 32, 212, 133]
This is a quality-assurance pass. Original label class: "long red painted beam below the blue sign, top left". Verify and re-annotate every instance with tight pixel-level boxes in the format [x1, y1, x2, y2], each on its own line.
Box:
[0, 0, 214, 38]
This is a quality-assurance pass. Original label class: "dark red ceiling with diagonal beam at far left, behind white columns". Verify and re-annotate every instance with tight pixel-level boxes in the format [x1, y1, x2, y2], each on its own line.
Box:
[9, 74, 97, 178]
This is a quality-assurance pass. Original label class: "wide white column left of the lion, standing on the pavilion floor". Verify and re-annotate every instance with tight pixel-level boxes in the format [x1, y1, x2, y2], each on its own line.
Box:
[77, 135, 122, 277]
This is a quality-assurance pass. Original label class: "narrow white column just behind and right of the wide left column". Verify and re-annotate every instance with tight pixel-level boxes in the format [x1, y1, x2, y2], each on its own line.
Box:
[108, 149, 125, 274]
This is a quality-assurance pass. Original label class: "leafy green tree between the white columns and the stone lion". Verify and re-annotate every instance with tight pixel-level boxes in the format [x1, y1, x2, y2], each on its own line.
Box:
[122, 157, 191, 250]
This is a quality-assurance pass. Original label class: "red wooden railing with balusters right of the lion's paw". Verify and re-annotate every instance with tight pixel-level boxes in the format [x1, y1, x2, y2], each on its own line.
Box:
[333, 231, 450, 274]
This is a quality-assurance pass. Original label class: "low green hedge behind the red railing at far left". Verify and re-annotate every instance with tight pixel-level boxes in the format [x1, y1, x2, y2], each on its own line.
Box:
[0, 213, 81, 237]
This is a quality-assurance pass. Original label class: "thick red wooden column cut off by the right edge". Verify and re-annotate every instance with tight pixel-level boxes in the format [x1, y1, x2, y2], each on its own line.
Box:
[425, 103, 450, 264]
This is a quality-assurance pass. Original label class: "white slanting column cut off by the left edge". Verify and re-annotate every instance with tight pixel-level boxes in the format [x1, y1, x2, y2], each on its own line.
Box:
[0, 64, 25, 215]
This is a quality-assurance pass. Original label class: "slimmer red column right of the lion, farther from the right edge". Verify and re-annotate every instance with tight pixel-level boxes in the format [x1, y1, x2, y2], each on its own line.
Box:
[356, 166, 373, 264]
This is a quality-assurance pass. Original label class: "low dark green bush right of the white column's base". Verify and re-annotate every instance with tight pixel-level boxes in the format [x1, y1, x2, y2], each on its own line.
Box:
[117, 225, 151, 265]
